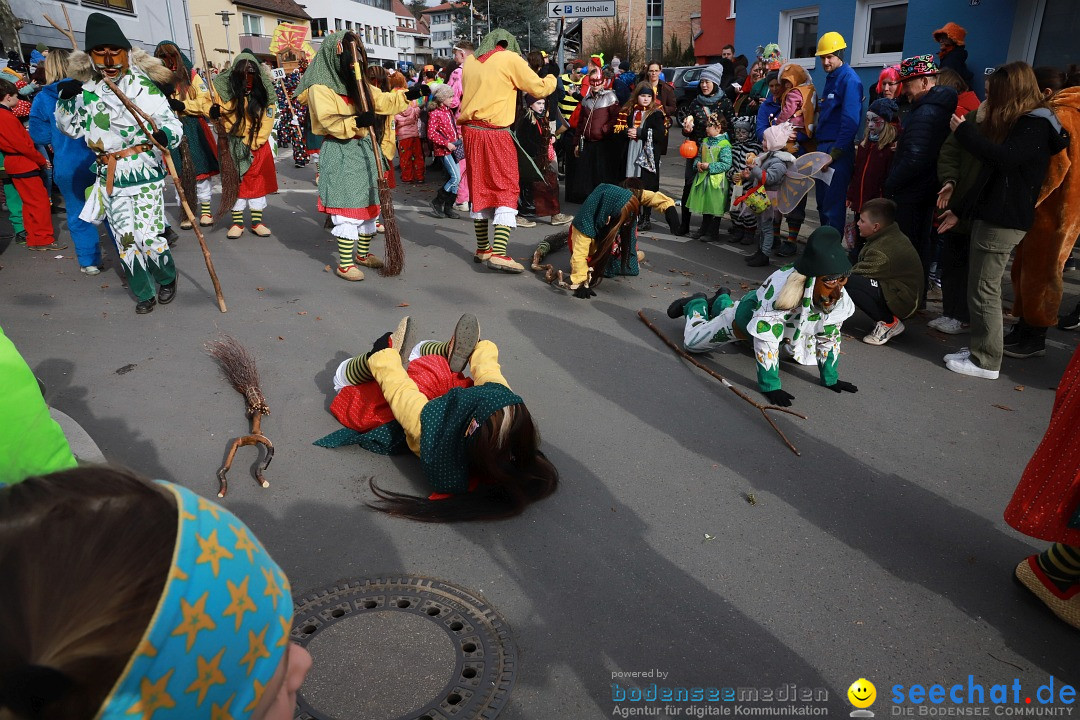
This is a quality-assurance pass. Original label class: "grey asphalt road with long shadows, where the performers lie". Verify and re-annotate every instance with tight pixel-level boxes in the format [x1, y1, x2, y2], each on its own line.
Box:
[0, 153, 1080, 720]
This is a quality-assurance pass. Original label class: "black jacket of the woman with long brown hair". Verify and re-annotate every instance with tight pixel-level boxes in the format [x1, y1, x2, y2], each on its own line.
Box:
[956, 110, 1069, 230]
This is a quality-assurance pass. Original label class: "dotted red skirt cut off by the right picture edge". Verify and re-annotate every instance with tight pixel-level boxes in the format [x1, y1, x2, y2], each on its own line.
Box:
[1005, 348, 1080, 546]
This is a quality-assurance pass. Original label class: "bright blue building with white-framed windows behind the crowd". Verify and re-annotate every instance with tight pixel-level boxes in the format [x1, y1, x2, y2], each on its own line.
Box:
[734, 0, 1080, 101]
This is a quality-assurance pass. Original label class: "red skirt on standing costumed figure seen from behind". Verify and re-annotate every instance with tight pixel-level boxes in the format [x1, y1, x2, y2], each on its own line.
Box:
[461, 125, 521, 212]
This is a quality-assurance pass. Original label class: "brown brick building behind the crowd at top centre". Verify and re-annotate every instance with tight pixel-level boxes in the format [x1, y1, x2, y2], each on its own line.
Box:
[581, 0, 699, 70]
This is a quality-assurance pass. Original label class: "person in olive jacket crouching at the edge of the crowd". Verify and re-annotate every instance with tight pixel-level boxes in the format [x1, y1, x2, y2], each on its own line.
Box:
[846, 198, 922, 345]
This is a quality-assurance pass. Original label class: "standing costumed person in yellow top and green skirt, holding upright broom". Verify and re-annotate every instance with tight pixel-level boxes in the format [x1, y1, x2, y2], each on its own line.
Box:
[298, 31, 429, 282]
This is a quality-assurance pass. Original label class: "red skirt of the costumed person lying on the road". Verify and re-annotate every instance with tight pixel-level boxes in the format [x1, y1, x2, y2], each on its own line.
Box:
[330, 355, 473, 433]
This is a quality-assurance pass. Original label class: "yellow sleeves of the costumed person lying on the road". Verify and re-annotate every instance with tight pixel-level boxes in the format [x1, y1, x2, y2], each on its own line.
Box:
[369, 343, 510, 456]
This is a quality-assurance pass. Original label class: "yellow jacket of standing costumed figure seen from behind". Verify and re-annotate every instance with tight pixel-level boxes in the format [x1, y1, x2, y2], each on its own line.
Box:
[458, 51, 557, 127]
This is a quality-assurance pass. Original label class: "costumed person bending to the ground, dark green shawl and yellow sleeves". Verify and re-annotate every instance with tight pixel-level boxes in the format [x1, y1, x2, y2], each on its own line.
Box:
[532, 178, 680, 300]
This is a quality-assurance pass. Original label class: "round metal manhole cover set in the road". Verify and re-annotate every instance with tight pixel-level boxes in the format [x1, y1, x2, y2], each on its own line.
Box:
[292, 576, 517, 720]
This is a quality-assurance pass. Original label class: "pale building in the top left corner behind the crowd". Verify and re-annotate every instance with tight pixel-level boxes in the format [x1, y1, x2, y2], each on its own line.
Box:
[9, 0, 194, 58]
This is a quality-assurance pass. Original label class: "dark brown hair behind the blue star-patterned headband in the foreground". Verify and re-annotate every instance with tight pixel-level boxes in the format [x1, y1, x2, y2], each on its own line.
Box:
[0, 467, 176, 720]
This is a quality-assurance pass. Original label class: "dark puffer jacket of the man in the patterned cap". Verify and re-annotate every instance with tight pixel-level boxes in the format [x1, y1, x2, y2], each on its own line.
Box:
[885, 85, 957, 202]
